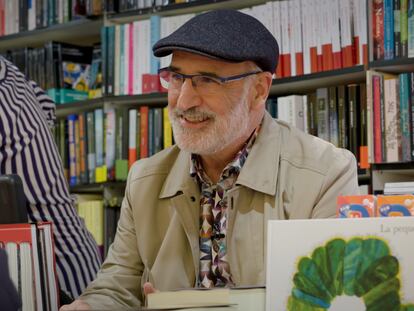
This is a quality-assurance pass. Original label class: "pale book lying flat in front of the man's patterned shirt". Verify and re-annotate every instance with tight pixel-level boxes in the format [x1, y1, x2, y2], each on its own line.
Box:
[147, 287, 265, 311]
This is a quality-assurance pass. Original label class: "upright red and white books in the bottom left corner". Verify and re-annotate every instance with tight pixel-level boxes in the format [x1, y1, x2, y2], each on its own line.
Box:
[0, 222, 59, 311]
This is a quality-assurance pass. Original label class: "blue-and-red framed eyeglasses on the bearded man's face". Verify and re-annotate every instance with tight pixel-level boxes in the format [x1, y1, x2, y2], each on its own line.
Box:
[158, 67, 262, 94]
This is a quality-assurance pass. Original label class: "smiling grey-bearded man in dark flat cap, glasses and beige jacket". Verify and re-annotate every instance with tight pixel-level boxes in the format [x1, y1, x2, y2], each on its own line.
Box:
[62, 10, 358, 310]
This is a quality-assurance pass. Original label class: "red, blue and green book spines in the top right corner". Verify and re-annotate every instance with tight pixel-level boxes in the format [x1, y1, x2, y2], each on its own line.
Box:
[371, 0, 414, 60]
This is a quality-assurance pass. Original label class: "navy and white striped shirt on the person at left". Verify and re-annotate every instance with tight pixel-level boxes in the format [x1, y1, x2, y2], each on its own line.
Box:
[0, 56, 101, 298]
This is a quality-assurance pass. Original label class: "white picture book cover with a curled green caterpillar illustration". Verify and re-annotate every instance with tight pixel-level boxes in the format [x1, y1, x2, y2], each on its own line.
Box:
[266, 217, 414, 311]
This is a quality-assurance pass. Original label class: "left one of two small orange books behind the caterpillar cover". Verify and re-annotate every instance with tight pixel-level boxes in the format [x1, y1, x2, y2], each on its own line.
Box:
[336, 195, 375, 218]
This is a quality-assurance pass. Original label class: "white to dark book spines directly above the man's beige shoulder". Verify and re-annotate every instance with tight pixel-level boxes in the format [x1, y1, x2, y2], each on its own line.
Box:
[268, 84, 369, 169]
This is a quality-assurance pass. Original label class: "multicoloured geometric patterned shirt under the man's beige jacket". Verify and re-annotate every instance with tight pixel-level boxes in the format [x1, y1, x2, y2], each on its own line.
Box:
[190, 127, 260, 288]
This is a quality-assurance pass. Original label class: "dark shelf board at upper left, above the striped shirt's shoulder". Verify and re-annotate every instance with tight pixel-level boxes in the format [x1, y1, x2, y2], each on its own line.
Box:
[0, 18, 103, 51]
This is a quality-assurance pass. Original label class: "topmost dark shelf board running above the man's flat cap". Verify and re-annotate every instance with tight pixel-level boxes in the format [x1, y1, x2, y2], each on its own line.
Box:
[107, 0, 266, 24]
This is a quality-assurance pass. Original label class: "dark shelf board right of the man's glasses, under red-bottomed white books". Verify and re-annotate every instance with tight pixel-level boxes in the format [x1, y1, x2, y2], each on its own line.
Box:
[270, 65, 365, 96]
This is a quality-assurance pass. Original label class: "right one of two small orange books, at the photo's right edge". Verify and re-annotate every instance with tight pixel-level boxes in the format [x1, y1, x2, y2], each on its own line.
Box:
[377, 194, 414, 217]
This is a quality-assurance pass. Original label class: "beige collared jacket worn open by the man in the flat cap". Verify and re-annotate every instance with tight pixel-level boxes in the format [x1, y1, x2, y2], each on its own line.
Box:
[81, 113, 358, 309]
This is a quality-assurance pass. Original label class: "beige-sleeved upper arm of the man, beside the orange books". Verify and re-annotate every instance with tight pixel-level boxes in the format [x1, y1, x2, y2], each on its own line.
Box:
[312, 149, 359, 218]
